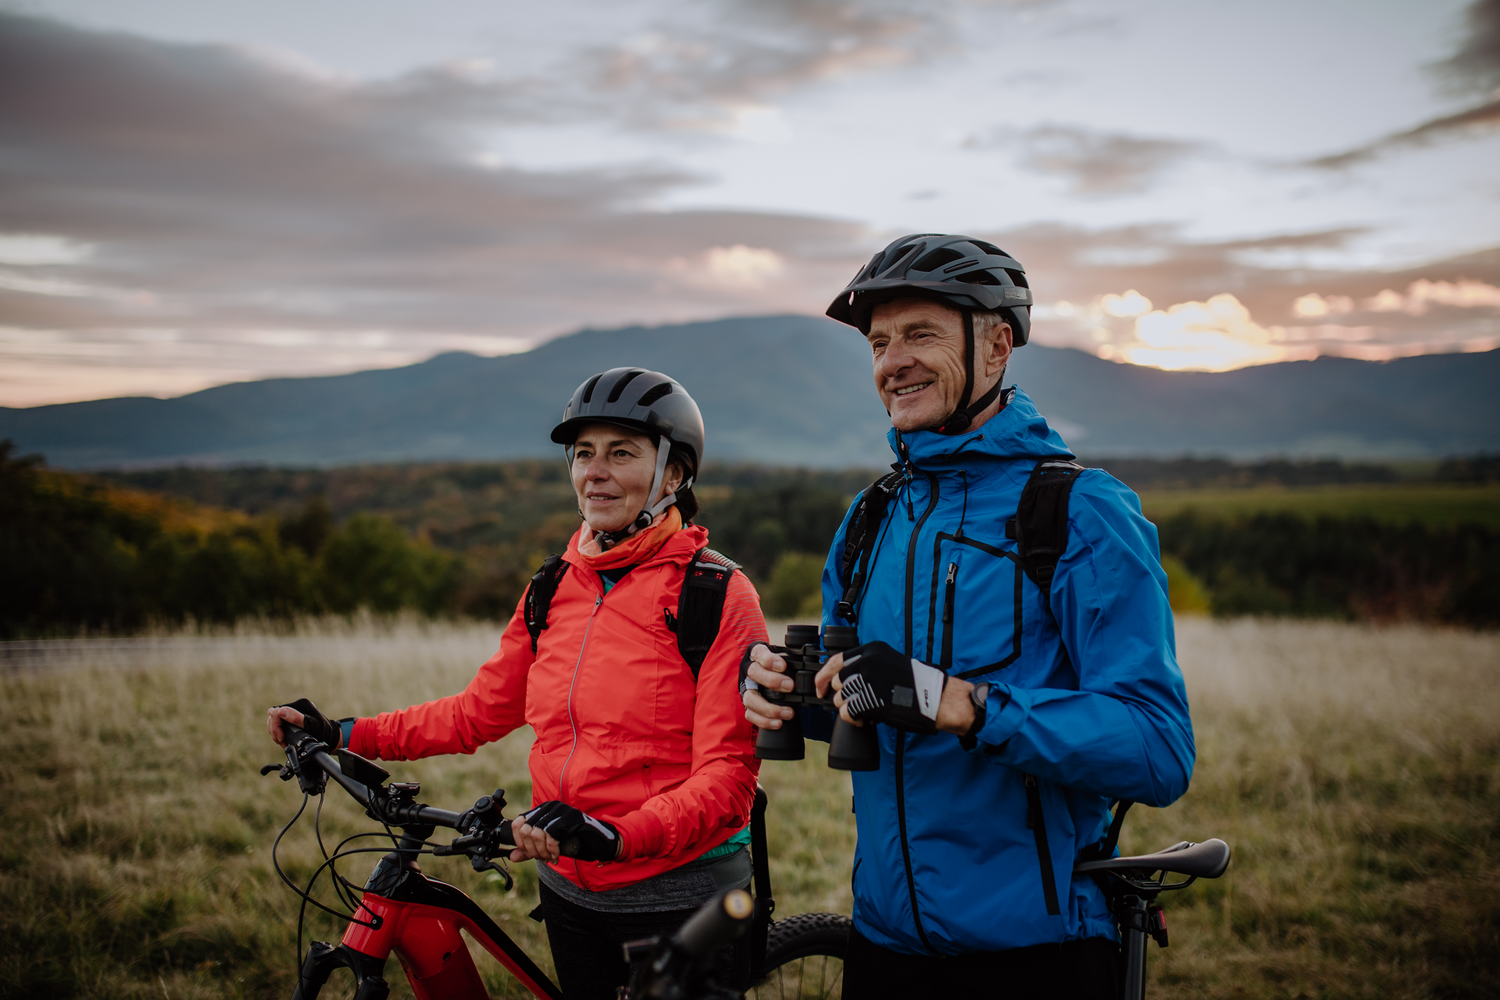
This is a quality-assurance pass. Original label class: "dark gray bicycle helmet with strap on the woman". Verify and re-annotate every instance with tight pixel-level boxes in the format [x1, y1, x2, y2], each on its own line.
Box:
[552, 367, 704, 538]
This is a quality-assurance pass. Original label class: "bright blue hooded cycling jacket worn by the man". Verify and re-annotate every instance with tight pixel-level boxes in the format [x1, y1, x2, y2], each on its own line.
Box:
[806, 391, 1194, 955]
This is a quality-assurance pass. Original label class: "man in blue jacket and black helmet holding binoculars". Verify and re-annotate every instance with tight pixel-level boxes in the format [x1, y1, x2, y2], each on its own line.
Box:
[743, 234, 1194, 1000]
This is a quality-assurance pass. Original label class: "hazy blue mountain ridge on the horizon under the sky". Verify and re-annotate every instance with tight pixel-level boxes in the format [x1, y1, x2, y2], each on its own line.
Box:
[0, 316, 1500, 468]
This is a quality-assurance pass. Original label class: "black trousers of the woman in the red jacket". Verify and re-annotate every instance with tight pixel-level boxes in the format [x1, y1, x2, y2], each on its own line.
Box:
[540, 883, 735, 1000]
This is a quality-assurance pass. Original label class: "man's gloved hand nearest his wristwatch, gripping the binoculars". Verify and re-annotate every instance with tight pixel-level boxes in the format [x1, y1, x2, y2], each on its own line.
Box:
[815, 642, 974, 735]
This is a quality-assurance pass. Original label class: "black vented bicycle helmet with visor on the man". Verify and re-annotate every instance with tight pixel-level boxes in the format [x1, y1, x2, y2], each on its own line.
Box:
[828, 232, 1032, 433]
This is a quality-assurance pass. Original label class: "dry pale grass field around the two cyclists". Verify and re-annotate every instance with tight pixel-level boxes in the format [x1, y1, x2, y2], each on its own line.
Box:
[0, 619, 1500, 1000]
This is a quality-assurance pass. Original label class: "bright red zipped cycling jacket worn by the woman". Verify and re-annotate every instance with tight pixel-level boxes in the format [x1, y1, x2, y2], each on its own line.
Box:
[350, 526, 767, 891]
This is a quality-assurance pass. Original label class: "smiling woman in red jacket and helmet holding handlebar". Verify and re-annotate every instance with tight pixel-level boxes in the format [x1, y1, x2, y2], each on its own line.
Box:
[267, 367, 767, 1000]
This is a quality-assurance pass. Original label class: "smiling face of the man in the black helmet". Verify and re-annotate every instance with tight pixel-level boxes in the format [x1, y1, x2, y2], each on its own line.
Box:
[867, 298, 1010, 432]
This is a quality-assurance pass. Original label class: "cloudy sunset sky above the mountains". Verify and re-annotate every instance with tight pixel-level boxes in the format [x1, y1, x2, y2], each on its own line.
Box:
[0, 0, 1500, 406]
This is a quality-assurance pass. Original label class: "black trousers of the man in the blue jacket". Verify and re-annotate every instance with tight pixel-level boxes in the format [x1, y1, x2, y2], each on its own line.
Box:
[843, 931, 1121, 1000]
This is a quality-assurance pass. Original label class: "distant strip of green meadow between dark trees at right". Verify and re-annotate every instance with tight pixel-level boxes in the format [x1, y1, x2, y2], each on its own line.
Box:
[1140, 483, 1500, 528]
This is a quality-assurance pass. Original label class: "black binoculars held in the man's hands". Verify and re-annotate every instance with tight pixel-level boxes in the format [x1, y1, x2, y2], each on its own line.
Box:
[755, 625, 881, 771]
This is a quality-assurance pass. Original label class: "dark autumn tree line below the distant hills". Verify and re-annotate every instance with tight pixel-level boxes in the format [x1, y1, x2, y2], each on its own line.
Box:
[0, 442, 1500, 637]
